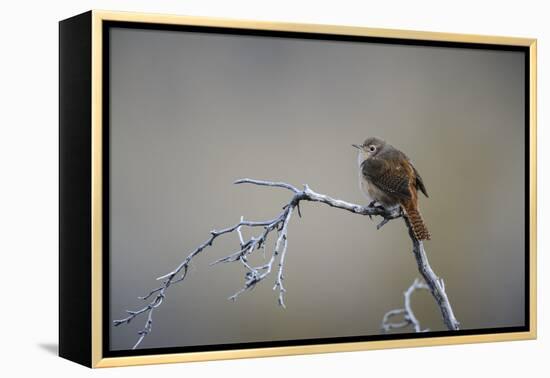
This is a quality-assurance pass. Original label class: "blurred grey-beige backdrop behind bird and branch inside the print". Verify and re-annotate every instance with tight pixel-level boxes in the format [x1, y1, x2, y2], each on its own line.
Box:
[110, 29, 525, 350]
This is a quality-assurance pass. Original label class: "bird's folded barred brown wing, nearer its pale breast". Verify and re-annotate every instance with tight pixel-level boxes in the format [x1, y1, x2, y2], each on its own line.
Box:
[361, 159, 412, 200]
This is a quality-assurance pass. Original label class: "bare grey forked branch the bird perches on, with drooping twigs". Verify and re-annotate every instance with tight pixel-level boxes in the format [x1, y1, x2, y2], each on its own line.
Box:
[113, 179, 458, 349]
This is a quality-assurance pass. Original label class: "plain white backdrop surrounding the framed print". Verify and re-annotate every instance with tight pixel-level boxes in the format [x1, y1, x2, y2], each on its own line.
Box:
[0, 0, 550, 377]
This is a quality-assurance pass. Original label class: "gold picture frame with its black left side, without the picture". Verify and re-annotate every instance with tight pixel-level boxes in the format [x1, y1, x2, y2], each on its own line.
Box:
[60, 10, 537, 368]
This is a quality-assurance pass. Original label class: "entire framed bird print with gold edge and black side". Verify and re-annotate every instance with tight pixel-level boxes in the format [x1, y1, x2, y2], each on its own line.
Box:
[59, 11, 536, 367]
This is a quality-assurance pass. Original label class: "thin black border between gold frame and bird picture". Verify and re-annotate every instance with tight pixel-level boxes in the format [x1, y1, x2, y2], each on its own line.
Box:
[101, 21, 531, 357]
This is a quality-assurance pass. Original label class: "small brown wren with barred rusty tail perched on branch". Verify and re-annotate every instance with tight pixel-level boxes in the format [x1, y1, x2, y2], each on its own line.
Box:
[353, 138, 431, 240]
